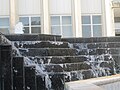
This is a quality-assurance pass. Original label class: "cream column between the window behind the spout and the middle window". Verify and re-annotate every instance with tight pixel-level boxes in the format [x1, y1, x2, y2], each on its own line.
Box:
[41, 0, 50, 34]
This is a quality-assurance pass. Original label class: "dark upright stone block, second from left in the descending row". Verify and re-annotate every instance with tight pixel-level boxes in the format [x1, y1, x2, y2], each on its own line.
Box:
[12, 57, 25, 90]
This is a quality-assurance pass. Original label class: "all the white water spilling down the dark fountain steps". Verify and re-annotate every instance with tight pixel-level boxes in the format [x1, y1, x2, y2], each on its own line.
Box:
[1, 35, 116, 90]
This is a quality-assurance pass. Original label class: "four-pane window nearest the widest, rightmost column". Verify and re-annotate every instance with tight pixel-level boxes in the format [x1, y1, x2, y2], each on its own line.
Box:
[82, 15, 102, 37]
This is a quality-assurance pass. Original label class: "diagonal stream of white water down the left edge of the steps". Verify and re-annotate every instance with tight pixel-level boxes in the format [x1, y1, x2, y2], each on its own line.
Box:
[1, 35, 51, 90]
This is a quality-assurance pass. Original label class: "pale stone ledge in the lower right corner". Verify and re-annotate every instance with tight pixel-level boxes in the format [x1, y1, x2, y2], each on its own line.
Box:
[65, 75, 120, 90]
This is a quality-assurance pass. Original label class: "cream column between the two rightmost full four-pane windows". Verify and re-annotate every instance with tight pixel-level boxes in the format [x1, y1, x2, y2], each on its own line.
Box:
[72, 0, 82, 37]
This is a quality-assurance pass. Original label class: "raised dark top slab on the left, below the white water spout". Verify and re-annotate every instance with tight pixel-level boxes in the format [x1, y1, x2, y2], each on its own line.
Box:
[5, 34, 61, 41]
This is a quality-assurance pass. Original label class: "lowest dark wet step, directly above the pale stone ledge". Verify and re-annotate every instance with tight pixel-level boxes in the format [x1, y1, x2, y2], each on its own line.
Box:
[40, 70, 95, 90]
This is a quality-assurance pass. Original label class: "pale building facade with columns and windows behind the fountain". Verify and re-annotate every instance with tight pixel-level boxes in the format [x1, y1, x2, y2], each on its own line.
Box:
[0, 0, 117, 37]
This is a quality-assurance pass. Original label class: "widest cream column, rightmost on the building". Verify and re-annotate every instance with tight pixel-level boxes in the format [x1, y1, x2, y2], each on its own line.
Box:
[102, 0, 115, 36]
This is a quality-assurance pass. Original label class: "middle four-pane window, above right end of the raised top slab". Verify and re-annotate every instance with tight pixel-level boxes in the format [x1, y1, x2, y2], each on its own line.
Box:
[51, 16, 72, 37]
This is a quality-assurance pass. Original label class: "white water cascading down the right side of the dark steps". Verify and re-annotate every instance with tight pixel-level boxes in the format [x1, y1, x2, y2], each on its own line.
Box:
[69, 43, 116, 77]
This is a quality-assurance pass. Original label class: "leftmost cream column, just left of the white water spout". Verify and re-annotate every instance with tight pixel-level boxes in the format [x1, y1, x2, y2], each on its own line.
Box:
[10, 0, 19, 33]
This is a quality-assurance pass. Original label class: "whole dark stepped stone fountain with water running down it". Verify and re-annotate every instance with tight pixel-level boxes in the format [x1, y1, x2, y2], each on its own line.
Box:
[0, 34, 120, 90]
